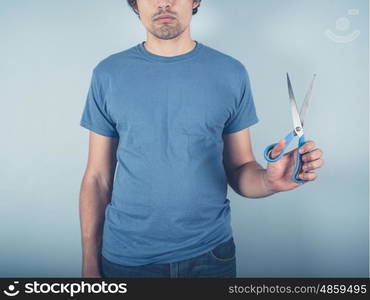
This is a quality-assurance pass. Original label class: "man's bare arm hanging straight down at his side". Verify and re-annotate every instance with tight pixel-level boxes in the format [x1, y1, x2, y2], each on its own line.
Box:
[80, 131, 118, 277]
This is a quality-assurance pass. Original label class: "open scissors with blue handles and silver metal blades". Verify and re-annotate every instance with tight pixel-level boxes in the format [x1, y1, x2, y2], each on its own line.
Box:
[264, 73, 316, 183]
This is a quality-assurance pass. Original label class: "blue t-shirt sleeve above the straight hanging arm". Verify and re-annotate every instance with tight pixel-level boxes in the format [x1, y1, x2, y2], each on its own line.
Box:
[80, 69, 119, 138]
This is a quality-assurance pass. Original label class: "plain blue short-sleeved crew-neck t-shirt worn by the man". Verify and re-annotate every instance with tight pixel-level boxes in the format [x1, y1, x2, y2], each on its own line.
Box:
[80, 41, 259, 266]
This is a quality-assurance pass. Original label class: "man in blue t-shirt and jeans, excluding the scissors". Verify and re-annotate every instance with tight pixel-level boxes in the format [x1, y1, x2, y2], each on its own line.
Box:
[80, 0, 323, 277]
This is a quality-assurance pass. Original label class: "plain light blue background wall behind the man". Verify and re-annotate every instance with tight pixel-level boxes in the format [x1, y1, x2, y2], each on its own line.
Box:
[0, 0, 369, 277]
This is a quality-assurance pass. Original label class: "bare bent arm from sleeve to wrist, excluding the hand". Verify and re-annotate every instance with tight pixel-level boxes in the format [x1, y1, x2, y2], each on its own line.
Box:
[223, 128, 275, 198]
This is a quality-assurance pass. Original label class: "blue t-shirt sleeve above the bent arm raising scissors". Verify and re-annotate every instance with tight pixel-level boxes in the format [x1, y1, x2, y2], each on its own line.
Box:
[223, 66, 259, 134]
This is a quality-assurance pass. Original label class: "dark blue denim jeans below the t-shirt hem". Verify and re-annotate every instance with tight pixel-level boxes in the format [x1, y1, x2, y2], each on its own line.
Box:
[101, 237, 236, 278]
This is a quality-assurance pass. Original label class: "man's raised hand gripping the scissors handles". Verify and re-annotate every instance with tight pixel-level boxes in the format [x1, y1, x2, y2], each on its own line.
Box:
[265, 139, 324, 192]
